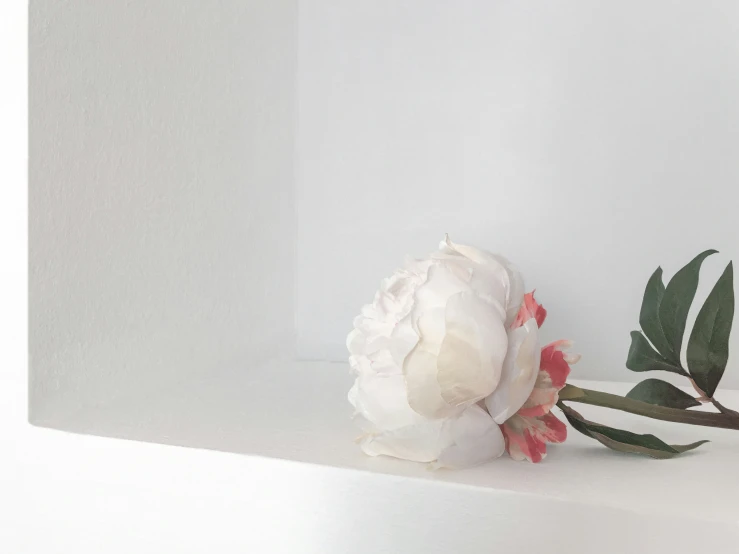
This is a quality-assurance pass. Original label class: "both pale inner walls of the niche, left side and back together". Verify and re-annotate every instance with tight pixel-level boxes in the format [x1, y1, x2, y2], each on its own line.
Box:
[29, 0, 739, 404]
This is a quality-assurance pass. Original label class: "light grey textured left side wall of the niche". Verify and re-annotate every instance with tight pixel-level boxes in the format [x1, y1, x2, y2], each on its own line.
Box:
[29, 0, 297, 424]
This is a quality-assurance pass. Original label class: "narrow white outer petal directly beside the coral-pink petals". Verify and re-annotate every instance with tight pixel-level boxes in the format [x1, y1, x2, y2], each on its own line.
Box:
[485, 318, 541, 424]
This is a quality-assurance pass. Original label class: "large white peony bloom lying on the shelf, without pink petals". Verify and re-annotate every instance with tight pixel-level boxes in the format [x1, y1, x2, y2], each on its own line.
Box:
[347, 237, 541, 467]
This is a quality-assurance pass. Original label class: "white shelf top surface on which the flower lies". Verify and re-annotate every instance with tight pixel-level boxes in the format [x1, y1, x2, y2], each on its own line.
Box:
[30, 362, 739, 544]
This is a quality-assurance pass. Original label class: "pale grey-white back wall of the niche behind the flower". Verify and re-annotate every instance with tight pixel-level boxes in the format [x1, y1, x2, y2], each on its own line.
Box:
[297, 0, 739, 386]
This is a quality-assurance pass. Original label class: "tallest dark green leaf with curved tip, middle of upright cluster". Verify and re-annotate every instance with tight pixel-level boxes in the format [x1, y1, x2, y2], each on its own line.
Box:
[659, 250, 716, 361]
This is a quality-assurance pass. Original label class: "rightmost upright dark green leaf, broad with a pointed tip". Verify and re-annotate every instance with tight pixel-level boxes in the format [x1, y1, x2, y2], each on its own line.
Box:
[687, 262, 734, 397]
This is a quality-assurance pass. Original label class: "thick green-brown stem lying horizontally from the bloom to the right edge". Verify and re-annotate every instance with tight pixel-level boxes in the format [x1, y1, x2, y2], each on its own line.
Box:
[559, 385, 739, 430]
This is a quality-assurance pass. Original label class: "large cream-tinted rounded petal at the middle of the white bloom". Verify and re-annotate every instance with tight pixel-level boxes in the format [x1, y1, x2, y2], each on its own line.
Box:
[437, 292, 508, 406]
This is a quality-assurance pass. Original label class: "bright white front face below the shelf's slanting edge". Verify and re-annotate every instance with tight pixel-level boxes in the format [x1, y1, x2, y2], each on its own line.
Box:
[8, 420, 739, 554]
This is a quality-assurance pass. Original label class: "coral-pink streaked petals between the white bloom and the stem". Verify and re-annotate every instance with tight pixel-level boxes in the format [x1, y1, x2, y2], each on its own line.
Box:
[500, 292, 580, 463]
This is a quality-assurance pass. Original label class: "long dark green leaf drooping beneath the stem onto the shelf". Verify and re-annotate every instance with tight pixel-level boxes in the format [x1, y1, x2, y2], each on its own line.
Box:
[558, 402, 708, 459]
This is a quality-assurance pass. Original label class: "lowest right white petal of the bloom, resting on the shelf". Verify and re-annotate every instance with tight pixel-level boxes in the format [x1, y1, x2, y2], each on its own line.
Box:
[433, 404, 505, 469]
